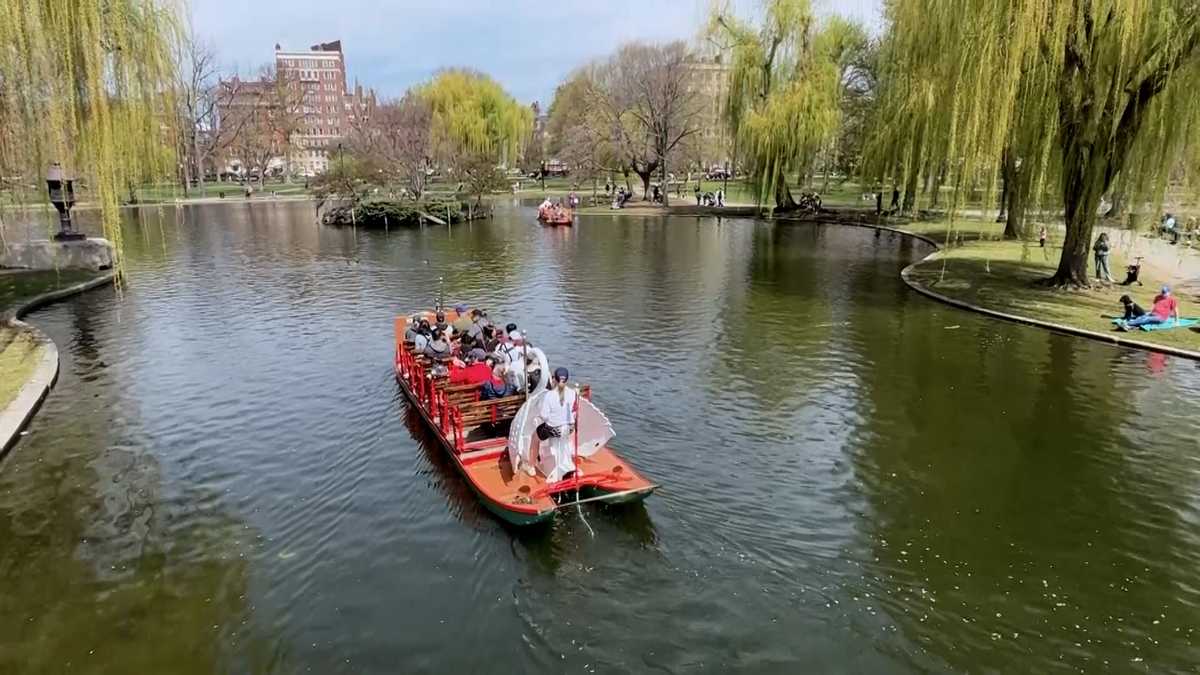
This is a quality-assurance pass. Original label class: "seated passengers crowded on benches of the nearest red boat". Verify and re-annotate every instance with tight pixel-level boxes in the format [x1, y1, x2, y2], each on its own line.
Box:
[404, 305, 542, 400]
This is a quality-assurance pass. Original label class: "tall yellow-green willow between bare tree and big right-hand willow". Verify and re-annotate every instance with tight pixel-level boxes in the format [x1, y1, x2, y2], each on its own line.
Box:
[708, 0, 866, 210]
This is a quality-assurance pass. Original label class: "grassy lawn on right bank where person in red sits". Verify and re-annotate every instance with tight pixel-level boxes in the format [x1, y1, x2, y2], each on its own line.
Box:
[906, 230, 1200, 351]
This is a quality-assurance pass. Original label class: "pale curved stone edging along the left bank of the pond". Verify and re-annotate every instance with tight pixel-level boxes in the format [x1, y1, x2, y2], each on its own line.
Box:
[0, 271, 115, 456]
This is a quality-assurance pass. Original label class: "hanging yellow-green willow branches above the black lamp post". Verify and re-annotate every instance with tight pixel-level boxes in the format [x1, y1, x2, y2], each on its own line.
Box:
[0, 0, 180, 260]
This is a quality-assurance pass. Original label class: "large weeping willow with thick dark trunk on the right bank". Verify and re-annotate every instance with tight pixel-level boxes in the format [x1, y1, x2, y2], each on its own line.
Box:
[865, 0, 1200, 287]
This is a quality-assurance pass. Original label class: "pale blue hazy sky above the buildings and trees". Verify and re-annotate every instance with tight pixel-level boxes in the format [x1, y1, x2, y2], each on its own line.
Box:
[191, 0, 882, 107]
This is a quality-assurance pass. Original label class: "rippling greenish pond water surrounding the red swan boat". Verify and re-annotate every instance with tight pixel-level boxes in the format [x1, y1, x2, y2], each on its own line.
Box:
[0, 199, 1200, 673]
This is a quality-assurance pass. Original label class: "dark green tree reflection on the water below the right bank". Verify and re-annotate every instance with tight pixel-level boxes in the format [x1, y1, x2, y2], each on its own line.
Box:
[852, 309, 1200, 670]
